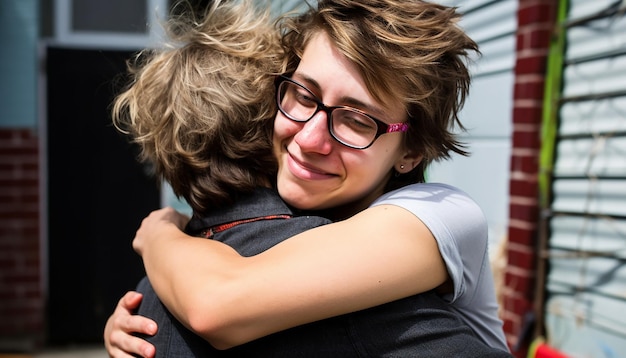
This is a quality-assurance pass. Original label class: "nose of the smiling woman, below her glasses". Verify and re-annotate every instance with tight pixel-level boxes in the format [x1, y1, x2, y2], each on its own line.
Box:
[294, 111, 333, 154]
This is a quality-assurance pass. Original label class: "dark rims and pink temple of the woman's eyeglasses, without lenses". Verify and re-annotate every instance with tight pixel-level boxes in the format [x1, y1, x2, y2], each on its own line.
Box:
[276, 75, 409, 149]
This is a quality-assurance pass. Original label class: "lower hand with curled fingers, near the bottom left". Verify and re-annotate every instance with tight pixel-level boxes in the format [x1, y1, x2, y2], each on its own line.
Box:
[104, 291, 157, 358]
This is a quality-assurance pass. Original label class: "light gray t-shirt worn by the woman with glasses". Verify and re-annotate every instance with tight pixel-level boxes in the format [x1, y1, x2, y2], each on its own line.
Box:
[372, 183, 508, 351]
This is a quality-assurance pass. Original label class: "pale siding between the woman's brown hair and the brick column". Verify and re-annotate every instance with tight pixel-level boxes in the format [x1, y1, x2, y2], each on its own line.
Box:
[429, 0, 518, 258]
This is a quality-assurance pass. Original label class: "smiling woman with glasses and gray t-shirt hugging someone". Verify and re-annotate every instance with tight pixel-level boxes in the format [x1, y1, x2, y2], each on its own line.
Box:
[105, 0, 507, 356]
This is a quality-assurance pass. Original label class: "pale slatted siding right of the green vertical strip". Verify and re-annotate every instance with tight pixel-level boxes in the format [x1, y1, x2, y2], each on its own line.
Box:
[545, 0, 626, 357]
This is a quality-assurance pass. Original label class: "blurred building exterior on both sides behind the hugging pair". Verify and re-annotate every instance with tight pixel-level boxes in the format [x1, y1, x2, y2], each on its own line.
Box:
[0, 0, 626, 357]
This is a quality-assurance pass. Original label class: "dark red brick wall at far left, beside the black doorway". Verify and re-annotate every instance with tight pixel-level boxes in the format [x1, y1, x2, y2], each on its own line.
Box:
[0, 129, 44, 352]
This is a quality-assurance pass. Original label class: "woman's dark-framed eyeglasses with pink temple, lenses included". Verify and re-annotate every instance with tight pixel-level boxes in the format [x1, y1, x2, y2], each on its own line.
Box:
[276, 76, 409, 149]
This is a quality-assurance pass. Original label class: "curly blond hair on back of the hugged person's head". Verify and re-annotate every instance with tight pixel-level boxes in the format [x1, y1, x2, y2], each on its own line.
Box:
[113, 0, 284, 214]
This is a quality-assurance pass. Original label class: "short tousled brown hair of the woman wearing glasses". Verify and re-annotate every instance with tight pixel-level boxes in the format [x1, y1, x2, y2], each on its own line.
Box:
[281, 0, 478, 190]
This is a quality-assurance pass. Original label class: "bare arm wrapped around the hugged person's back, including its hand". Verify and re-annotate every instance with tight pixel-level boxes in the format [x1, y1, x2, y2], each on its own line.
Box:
[133, 205, 448, 348]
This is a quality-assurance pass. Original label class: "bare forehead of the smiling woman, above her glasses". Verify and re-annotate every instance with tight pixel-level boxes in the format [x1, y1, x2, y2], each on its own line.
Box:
[293, 31, 406, 121]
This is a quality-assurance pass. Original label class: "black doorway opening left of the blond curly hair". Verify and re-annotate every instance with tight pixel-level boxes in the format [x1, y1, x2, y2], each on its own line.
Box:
[43, 47, 160, 345]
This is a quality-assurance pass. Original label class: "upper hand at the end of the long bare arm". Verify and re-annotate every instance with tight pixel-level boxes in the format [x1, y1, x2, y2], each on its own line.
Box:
[133, 207, 189, 255]
